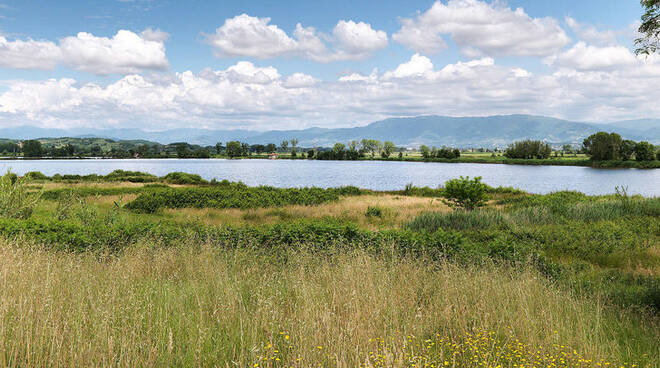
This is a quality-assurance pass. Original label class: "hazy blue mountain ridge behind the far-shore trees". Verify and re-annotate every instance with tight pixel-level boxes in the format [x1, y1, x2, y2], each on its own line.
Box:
[0, 115, 660, 147]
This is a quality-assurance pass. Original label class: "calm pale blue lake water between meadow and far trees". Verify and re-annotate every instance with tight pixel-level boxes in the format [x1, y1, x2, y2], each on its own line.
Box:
[0, 159, 660, 196]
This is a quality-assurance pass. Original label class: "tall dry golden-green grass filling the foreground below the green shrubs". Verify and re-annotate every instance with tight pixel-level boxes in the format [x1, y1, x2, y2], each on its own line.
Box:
[0, 242, 660, 367]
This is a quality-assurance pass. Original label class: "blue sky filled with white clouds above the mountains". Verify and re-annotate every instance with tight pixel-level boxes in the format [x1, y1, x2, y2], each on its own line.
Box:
[0, 0, 660, 130]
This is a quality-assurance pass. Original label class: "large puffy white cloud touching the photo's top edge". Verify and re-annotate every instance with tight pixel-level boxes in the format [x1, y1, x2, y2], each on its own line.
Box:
[392, 0, 570, 57]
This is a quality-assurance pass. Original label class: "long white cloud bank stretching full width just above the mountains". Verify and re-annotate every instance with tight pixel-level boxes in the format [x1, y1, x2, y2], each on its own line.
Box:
[0, 55, 660, 129]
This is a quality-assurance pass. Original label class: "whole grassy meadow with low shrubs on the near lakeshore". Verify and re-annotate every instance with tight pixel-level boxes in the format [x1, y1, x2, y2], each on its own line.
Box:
[0, 172, 660, 367]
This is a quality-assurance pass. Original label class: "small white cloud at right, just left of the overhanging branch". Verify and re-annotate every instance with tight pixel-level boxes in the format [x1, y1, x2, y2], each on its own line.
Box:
[548, 41, 637, 70]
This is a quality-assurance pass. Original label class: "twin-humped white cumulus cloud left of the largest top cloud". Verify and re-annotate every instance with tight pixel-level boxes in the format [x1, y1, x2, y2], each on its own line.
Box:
[205, 14, 388, 62]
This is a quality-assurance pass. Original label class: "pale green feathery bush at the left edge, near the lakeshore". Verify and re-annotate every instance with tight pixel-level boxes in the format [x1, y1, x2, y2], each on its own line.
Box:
[0, 172, 40, 219]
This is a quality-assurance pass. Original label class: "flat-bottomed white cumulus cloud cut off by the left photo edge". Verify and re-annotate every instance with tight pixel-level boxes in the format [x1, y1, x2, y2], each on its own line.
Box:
[0, 29, 169, 75]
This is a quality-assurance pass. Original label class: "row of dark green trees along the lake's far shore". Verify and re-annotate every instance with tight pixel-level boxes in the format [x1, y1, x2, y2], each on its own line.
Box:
[5, 132, 660, 161]
